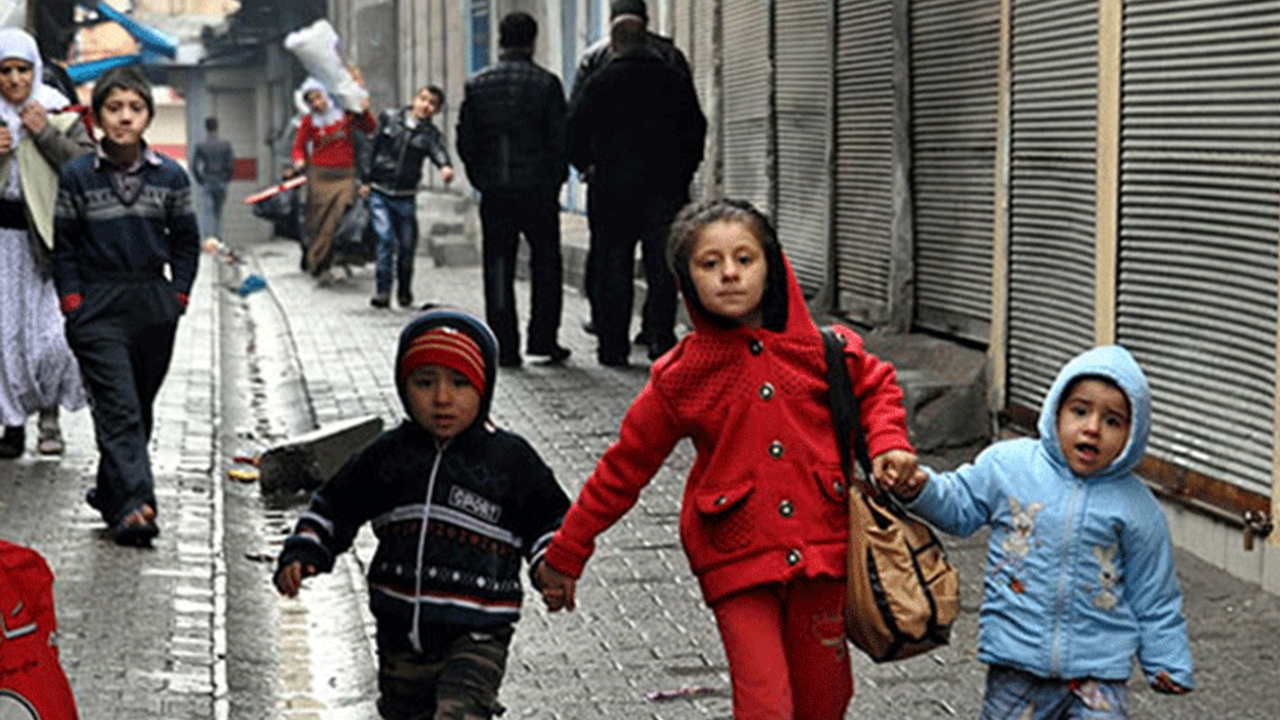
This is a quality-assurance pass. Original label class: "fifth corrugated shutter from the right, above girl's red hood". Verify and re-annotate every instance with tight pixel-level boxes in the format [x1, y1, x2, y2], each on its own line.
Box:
[774, 0, 832, 296]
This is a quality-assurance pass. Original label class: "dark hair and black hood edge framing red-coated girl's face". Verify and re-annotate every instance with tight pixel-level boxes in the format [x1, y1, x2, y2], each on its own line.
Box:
[667, 197, 787, 332]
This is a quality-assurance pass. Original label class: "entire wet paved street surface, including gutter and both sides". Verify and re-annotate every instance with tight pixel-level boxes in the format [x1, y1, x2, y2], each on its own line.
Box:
[0, 197, 1280, 720]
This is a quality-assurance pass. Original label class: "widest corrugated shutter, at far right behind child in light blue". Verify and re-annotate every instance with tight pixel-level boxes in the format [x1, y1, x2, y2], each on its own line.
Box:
[1117, 0, 1280, 495]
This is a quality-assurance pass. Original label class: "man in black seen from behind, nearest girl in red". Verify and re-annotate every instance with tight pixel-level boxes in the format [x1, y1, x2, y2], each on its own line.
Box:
[568, 14, 707, 365]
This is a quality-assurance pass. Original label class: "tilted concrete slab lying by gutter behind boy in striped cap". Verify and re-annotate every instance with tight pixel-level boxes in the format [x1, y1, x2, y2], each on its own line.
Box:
[259, 415, 383, 493]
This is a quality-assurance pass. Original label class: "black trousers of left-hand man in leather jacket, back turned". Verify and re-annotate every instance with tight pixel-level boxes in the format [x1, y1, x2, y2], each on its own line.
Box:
[480, 187, 564, 364]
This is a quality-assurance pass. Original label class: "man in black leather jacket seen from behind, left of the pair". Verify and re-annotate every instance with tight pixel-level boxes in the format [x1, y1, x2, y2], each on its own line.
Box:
[458, 13, 570, 368]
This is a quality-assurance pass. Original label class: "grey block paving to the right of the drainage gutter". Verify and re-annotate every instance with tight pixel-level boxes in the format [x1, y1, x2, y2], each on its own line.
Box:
[235, 225, 1280, 720]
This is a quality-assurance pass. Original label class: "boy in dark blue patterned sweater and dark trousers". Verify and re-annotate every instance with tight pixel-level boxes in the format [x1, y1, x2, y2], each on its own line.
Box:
[52, 67, 200, 546]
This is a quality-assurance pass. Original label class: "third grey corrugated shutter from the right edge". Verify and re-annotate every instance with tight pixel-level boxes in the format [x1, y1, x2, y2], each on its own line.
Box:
[911, 0, 1000, 343]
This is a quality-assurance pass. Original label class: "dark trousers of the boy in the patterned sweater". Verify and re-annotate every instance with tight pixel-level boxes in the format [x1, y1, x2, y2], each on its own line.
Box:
[67, 277, 182, 525]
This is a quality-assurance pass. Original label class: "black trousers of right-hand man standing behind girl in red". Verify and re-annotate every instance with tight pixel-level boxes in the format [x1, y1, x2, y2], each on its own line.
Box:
[588, 182, 689, 364]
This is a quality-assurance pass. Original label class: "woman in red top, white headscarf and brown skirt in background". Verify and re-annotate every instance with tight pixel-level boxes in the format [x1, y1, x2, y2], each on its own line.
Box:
[293, 78, 378, 277]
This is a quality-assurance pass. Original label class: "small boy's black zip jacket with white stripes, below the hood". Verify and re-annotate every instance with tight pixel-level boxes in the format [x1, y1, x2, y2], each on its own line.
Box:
[279, 420, 568, 651]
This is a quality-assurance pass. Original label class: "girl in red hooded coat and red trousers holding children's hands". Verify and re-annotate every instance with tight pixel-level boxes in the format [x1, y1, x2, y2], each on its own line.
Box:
[538, 200, 915, 720]
